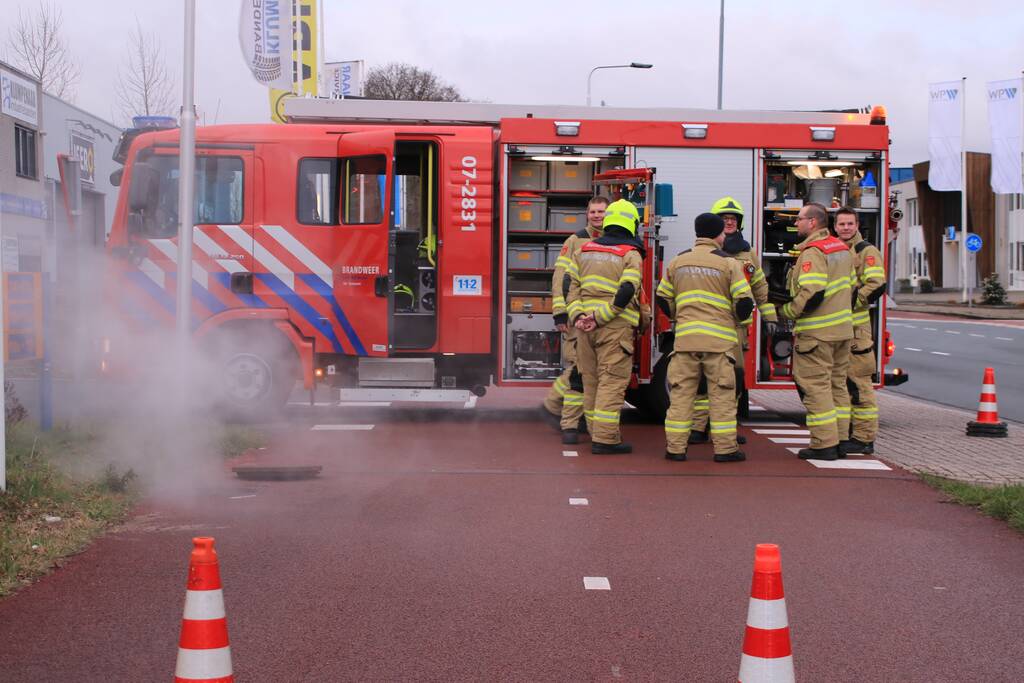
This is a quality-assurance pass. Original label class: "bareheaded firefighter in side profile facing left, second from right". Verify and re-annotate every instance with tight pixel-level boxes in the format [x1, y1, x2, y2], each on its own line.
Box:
[779, 203, 855, 460]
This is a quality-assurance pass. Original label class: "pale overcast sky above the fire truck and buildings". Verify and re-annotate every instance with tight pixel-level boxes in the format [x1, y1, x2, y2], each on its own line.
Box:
[8, 0, 1024, 165]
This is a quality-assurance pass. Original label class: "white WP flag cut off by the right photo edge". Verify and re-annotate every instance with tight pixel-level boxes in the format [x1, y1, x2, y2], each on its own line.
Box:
[985, 78, 1024, 195]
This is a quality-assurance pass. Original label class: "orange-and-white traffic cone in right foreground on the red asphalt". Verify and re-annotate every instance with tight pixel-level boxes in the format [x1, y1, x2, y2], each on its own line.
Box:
[739, 543, 796, 683]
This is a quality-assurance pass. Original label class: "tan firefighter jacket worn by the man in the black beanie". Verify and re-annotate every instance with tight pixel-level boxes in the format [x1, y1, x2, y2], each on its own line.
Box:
[657, 238, 754, 352]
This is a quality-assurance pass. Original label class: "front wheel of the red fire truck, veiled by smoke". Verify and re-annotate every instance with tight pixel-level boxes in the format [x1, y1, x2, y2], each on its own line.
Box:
[205, 326, 298, 422]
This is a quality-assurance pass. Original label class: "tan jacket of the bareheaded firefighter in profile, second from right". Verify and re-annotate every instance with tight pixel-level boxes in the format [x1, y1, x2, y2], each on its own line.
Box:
[779, 229, 856, 341]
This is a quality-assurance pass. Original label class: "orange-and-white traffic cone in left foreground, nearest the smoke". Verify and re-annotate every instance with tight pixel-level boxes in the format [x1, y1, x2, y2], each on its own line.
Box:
[174, 537, 234, 683]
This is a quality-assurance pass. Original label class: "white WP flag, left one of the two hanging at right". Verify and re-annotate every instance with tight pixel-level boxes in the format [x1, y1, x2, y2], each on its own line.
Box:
[928, 81, 964, 193]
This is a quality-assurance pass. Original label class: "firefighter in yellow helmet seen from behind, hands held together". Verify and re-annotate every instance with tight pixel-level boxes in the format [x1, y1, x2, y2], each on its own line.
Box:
[566, 200, 644, 454]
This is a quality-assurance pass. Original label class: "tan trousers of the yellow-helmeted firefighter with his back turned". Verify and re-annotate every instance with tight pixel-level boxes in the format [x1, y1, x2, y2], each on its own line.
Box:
[577, 326, 634, 444]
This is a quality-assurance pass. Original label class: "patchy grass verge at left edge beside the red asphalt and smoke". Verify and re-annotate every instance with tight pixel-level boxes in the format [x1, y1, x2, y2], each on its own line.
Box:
[0, 422, 135, 596]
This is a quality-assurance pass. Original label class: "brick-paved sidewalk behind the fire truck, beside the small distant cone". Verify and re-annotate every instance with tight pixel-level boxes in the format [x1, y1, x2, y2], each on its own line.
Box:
[751, 389, 1024, 484]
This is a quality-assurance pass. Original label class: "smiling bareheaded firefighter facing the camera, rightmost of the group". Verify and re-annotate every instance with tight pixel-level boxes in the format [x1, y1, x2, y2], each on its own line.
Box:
[836, 207, 886, 456]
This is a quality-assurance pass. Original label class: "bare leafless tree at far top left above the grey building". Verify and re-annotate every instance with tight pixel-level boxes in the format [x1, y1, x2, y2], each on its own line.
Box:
[7, 3, 80, 100]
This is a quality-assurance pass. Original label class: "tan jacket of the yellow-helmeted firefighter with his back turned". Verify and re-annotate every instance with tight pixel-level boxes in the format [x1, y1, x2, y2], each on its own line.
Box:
[565, 238, 643, 328]
